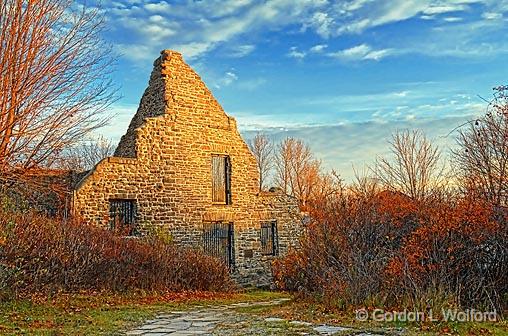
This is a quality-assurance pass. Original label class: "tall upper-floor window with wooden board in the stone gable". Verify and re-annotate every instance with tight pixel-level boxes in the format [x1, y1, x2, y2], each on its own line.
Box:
[212, 155, 231, 204]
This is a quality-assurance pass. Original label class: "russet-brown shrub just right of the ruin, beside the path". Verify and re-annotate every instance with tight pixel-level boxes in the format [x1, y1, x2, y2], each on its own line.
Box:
[274, 190, 414, 305]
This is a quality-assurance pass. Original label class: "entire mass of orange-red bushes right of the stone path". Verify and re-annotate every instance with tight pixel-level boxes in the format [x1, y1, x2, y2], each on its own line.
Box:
[274, 191, 508, 311]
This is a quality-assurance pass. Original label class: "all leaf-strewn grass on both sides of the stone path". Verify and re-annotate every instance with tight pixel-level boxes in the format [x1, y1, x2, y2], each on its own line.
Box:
[0, 291, 502, 336]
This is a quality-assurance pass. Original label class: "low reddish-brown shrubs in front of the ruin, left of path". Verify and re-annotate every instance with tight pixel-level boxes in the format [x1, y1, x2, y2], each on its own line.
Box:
[0, 210, 233, 293]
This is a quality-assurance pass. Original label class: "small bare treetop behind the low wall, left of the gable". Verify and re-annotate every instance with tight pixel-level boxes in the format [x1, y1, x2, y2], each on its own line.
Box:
[61, 136, 115, 172]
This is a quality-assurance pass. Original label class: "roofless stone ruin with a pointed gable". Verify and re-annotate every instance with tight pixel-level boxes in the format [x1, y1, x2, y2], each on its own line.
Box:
[73, 50, 302, 286]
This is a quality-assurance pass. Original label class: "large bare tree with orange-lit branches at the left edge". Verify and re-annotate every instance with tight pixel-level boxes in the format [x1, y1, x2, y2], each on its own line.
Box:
[0, 0, 115, 183]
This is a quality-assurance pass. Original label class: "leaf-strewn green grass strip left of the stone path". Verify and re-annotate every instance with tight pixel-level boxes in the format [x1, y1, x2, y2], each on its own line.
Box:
[0, 291, 287, 335]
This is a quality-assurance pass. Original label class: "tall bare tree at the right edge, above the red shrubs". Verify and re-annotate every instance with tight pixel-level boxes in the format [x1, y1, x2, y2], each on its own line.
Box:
[453, 86, 508, 206]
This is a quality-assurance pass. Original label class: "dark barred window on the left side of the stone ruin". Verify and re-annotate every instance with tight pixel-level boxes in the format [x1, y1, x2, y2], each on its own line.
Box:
[109, 199, 136, 235]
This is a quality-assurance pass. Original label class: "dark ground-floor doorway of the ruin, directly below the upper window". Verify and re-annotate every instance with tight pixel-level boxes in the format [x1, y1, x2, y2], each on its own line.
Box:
[203, 222, 234, 268]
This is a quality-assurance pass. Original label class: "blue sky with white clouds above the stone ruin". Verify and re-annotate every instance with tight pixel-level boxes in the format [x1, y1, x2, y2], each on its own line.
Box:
[93, 0, 508, 180]
